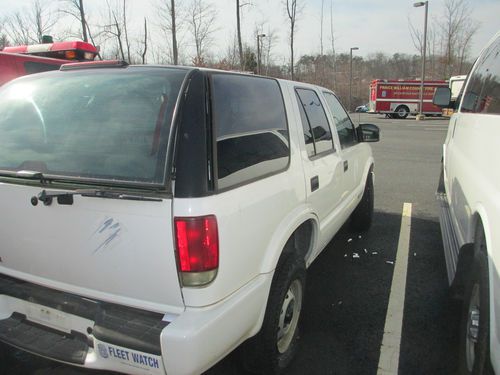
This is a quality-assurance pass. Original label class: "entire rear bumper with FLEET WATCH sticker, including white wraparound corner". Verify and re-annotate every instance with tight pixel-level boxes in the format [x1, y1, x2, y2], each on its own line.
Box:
[0, 274, 272, 374]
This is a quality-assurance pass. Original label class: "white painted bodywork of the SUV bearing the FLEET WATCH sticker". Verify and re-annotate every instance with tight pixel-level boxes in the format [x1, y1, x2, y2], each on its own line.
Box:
[0, 68, 374, 374]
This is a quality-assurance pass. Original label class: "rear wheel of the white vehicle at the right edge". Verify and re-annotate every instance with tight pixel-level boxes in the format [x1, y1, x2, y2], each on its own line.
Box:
[459, 227, 493, 375]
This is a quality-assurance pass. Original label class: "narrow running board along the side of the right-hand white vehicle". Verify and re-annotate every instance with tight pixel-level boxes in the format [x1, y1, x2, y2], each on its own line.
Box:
[436, 191, 460, 285]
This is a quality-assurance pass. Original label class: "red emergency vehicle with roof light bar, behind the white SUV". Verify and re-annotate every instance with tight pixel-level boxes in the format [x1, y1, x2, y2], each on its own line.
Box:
[0, 41, 98, 86]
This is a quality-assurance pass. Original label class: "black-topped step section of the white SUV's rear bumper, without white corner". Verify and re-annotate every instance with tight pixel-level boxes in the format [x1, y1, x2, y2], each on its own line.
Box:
[0, 274, 169, 374]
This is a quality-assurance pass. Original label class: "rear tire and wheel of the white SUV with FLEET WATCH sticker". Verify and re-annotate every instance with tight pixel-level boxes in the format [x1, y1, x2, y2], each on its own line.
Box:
[243, 254, 306, 374]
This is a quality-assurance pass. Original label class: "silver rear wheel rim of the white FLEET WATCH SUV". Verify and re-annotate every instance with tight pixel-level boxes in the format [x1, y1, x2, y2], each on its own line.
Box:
[277, 280, 302, 354]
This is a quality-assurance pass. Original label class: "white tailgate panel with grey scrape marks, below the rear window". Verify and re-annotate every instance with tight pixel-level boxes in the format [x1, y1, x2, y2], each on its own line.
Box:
[0, 183, 183, 313]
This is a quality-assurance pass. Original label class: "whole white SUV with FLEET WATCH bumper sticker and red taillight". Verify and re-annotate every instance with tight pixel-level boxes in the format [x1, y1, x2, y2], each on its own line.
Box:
[0, 62, 379, 374]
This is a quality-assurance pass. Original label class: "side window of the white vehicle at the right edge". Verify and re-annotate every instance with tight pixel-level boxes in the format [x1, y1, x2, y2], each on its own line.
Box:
[460, 38, 500, 114]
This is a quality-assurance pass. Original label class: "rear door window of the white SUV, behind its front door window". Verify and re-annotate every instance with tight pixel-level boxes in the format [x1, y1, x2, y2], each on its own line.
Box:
[295, 88, 334, 157]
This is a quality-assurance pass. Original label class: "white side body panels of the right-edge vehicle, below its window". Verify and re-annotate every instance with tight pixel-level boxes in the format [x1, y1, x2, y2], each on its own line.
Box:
[445, 113, 500, 372]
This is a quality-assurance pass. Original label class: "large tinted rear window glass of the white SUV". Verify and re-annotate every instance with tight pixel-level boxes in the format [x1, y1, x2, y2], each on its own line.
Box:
[0, 67, 187, 184]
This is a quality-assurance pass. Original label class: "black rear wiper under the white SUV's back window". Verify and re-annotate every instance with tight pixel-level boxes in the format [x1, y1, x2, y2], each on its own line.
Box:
[31, 189, 162, 206]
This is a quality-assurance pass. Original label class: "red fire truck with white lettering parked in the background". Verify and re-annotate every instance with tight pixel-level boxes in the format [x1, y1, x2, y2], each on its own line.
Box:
[368, 79, 448, 119]
